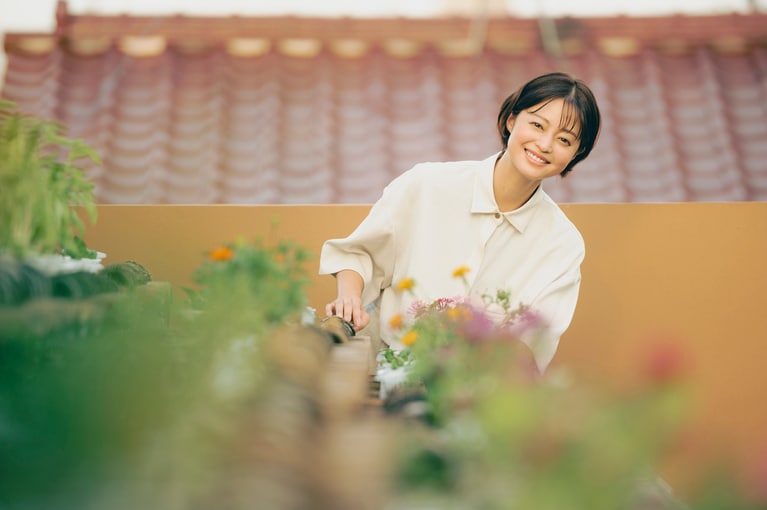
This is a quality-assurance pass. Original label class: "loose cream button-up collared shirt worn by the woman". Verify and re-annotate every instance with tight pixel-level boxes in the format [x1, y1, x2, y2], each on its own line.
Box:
[319, 154, 585, 370]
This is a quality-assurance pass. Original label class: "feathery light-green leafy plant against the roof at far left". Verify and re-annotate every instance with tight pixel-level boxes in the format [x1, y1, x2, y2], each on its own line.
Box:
[0, 101, 100, 258]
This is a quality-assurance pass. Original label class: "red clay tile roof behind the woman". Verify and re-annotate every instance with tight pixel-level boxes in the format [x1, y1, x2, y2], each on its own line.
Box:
[2, 5, 767, 203]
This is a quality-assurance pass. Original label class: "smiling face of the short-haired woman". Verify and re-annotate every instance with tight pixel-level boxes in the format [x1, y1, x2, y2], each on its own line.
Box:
[506, 98, 580, 181]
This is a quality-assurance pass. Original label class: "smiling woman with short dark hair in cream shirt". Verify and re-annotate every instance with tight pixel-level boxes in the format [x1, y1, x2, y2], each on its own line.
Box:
[320, 72, 600, 370]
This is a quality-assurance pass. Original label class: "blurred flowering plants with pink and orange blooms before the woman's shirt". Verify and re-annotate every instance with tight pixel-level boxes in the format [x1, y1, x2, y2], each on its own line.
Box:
[379, 274, 704, 510]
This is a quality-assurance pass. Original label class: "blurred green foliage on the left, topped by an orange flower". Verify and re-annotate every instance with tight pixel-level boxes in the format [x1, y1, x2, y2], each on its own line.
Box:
[0, 240, 324, 510]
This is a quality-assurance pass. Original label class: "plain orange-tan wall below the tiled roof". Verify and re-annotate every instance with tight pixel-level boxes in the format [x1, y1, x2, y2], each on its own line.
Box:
[86, 202, 767, 485]
